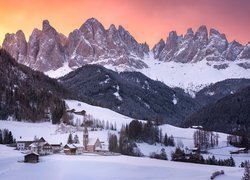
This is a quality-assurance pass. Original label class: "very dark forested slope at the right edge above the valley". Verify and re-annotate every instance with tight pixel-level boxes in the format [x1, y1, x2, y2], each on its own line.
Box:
[184, 86, 250, 141]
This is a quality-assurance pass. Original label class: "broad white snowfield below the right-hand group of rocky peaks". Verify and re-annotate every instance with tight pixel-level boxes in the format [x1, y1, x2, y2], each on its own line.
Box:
[139, 52, 250, 95]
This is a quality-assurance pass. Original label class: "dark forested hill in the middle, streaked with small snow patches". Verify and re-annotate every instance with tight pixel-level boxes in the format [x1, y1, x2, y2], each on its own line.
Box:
[59, 65, 199, 125]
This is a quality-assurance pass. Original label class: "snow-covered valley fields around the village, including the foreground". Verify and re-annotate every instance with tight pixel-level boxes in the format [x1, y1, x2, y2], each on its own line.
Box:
[0, 100, 250, 180]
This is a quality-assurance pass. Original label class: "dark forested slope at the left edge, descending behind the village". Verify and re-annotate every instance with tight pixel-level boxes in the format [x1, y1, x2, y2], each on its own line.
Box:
[0, 49, 68, 123]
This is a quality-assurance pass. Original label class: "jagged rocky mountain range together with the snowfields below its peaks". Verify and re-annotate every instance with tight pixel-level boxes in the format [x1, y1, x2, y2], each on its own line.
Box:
[2, 18, 250, 94]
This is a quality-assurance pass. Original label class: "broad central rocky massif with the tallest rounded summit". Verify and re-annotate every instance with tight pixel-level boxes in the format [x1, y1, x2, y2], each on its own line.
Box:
[66, 18, 149, 68]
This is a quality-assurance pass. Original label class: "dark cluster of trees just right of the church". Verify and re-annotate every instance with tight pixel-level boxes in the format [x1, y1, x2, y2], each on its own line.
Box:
[108, 120, 175, 159]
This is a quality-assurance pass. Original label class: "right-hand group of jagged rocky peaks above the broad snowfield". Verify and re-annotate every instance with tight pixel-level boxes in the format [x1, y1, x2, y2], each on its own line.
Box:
[153, 26, 250, 63]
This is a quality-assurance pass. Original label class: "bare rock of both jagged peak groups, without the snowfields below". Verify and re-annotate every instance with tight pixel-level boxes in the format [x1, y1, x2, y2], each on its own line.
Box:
[2, 18, 250, 72]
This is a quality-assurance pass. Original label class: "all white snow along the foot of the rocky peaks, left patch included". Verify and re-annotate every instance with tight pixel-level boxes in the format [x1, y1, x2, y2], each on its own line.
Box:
[45, 52, 250, 97]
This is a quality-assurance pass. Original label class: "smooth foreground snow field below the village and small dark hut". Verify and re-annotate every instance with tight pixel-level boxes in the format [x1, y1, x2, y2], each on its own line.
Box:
[0, 145, 244, 180]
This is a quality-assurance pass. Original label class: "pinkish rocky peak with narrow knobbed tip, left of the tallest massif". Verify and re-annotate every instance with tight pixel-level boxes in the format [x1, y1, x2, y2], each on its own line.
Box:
[26, 20, 65, 71]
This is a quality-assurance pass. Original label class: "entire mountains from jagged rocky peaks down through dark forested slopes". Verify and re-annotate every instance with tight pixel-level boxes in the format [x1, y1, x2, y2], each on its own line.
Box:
[0, 18, 250, 137]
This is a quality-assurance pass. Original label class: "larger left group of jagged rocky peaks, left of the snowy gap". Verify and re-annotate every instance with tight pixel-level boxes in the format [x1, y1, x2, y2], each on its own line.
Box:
[3, 18, 149, 72]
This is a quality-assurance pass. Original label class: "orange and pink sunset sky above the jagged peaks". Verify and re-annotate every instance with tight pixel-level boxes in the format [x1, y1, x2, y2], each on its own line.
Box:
[0, 0, 250, 47]
